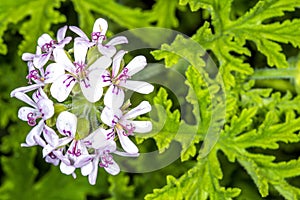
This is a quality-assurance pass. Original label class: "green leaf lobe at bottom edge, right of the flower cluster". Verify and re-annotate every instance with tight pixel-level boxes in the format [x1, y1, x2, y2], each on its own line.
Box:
[145, 150, 240, 200]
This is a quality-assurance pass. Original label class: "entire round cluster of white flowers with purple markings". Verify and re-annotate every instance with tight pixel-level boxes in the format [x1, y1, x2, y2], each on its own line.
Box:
[11, 18, 153, 184]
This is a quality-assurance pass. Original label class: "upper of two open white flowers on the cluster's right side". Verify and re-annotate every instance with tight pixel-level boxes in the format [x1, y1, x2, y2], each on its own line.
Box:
[102, 50, 154, 108]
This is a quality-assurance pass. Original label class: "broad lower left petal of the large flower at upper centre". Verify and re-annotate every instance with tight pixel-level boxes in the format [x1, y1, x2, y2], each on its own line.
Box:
[50, 74, 77, 102]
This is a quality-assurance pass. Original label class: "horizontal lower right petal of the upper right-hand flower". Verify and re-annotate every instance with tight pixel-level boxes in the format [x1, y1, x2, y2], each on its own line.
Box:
[119, 80, 154, 94]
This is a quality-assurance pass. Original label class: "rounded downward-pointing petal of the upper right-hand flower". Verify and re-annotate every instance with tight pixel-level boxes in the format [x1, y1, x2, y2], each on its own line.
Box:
[104, 85, 125, 109]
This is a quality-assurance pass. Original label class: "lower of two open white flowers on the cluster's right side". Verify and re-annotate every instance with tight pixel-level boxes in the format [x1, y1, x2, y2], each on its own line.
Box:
[101, 101, 152, 154]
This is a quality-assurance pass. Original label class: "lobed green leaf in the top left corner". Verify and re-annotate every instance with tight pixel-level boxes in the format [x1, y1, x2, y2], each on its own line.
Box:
[0, 0, 66, 54]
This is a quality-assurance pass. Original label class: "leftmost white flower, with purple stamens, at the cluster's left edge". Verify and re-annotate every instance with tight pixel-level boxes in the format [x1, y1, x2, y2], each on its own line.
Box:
[15, 88, 54, 147]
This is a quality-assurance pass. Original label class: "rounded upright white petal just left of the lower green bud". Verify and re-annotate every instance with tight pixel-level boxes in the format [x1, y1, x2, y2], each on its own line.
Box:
[56, 111, 77, 138]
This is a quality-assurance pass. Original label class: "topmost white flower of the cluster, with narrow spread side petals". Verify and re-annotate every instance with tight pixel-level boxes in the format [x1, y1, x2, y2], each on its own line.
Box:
[70, 18, 128, 57]
